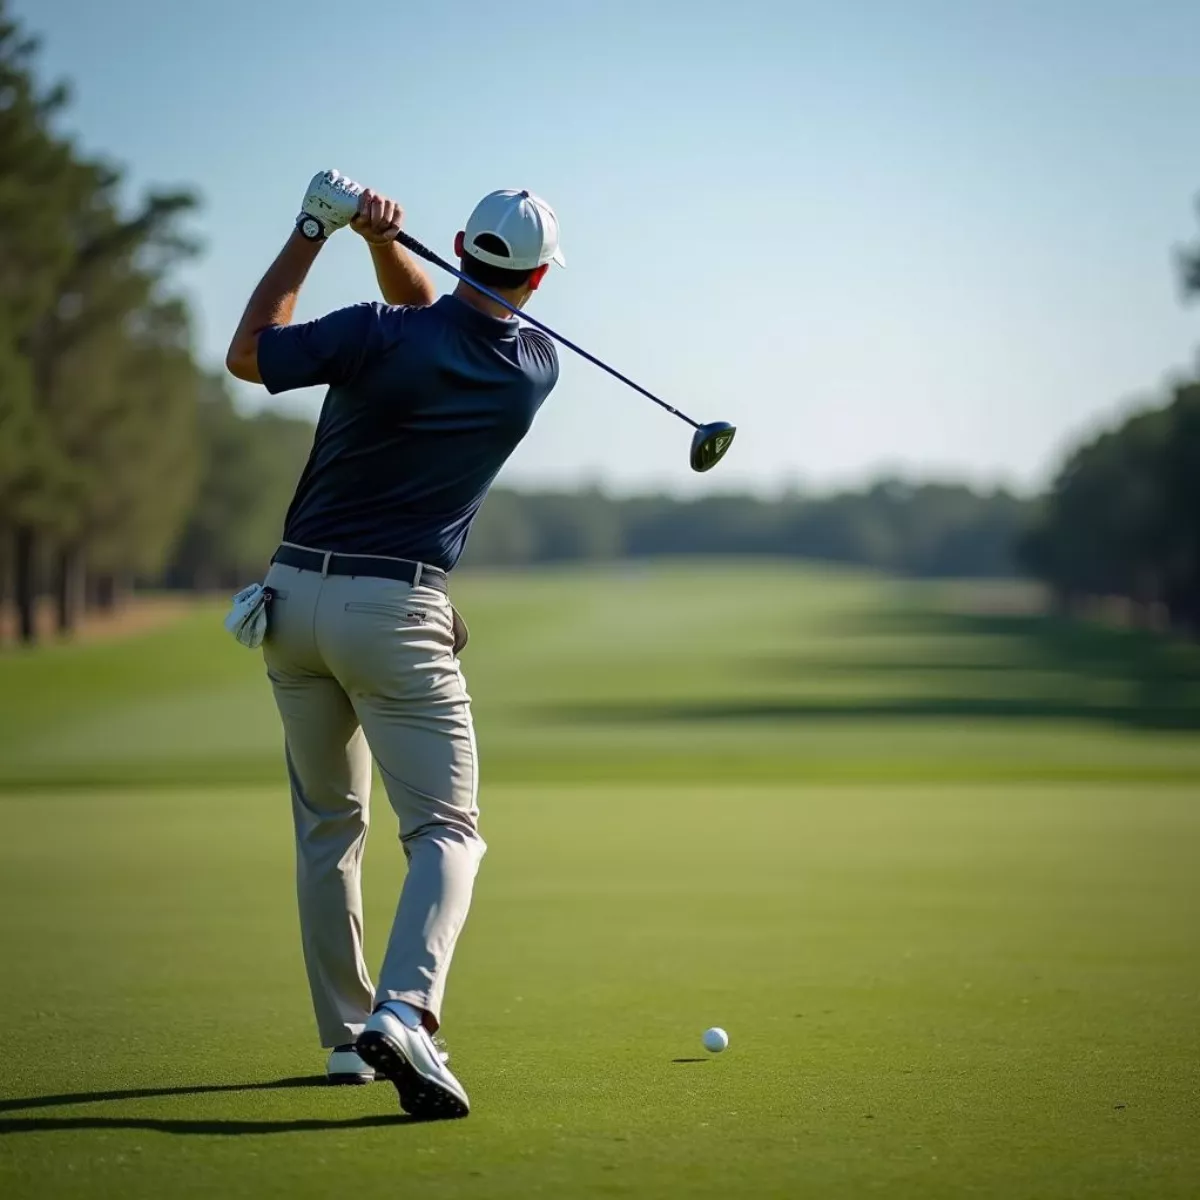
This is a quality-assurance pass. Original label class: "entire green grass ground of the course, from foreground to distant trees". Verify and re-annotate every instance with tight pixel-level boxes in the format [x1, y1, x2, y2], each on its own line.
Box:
[0, 565, 1200, 1200]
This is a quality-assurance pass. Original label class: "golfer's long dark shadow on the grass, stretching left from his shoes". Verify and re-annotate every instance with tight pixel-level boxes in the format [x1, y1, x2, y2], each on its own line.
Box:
[0, 1075, 414, 1136]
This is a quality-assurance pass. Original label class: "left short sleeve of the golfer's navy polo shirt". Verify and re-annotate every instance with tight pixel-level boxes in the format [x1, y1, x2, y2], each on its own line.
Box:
[258, 304, 383, 396]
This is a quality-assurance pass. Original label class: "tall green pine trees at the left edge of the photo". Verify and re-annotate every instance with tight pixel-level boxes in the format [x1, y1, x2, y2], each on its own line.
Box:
[0, 2, 200, 640]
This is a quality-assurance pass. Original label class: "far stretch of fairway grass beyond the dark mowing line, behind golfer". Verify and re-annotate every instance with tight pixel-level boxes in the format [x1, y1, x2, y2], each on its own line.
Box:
[7, 564, 1200, 790]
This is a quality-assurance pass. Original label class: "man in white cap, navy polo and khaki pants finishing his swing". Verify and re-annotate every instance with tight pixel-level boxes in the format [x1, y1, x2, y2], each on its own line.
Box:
[226, 172, 563, 1117]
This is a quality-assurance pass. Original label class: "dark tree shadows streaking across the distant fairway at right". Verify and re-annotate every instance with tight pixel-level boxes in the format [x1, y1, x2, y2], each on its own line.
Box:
[541, 607, 1200, 731]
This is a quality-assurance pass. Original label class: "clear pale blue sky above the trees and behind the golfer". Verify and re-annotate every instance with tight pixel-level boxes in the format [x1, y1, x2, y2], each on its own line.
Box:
[16, 0, 1200, 488]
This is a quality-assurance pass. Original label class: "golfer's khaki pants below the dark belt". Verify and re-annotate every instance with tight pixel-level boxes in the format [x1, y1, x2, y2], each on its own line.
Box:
[263, 563, 486, 1046]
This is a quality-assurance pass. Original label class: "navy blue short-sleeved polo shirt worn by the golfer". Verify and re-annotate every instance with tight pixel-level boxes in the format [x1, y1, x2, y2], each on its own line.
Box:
[258, 295, 558, 571]
